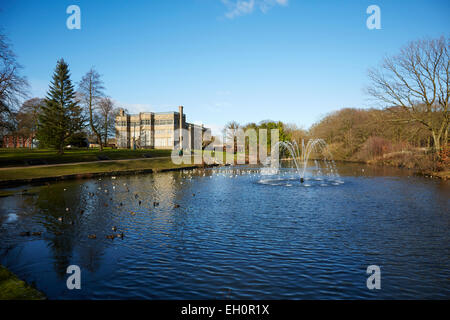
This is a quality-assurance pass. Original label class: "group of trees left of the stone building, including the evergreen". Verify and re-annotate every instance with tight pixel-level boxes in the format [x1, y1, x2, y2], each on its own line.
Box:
[0, 34, 119, 154]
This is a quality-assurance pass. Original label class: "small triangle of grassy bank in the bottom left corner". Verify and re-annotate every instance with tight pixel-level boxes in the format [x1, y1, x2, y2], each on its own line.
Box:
[0, 265, 45, 300]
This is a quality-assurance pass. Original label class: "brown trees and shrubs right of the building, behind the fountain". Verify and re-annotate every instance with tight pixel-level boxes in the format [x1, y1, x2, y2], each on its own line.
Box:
[225, 37, 450, 171]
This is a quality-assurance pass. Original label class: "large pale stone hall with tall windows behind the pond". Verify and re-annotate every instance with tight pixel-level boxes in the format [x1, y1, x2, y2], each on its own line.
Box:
[116, 106, 207, 150]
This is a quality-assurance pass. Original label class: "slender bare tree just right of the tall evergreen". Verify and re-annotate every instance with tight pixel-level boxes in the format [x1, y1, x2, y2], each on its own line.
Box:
[78, 67, 105, 150]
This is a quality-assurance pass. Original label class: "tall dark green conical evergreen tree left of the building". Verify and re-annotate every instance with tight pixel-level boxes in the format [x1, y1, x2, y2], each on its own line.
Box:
[37, 59, 84, 154]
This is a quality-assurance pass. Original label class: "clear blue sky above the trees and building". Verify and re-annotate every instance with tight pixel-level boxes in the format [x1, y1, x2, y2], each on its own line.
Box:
[0, 0, 450, 134]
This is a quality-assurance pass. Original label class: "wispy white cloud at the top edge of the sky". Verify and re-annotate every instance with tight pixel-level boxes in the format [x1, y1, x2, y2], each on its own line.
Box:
[221, 0, 288, 19]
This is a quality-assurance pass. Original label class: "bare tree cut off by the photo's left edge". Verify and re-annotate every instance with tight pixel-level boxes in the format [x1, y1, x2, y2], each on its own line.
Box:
[0, 33, 29, 131]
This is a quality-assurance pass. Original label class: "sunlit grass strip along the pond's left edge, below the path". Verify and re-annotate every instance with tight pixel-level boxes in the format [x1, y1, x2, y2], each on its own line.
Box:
[0, 158, 199, 181]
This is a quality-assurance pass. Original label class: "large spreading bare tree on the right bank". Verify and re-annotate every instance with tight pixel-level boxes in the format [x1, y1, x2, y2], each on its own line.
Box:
[367, 37, 450, 152]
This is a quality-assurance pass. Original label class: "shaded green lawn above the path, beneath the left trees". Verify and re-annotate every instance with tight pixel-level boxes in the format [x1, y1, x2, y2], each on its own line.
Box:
[0, 148, 171, 167]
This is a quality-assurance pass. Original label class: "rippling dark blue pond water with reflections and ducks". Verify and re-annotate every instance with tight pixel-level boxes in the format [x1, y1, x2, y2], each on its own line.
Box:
[0, 164, 450, 299]
